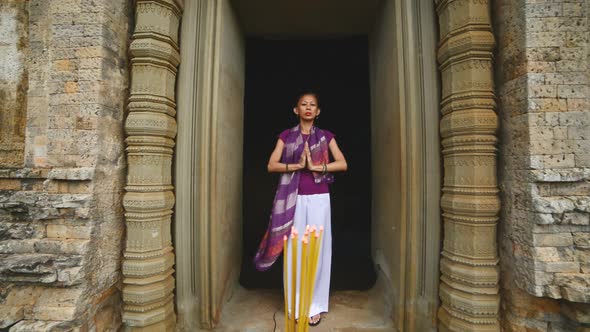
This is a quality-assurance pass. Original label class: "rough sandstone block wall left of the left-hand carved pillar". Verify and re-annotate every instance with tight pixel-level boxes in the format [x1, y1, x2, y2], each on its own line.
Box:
[0, 0, 132, 331]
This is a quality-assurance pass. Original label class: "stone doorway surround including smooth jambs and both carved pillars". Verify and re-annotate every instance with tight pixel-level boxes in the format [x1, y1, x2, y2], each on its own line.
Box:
[123, 0, 499, 331]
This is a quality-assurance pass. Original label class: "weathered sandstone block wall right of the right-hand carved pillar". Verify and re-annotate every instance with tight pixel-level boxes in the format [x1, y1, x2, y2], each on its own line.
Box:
[494, 0, 590, 331]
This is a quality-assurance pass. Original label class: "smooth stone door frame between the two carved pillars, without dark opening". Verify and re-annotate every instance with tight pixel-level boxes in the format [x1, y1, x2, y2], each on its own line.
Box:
[175, 1, 440, 330]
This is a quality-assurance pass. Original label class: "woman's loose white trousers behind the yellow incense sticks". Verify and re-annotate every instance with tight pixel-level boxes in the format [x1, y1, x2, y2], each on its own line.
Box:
[283, 194, 332, 318]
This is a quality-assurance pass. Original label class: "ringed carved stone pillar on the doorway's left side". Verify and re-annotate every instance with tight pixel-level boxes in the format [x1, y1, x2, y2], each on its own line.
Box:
[123, 0, 182, 331]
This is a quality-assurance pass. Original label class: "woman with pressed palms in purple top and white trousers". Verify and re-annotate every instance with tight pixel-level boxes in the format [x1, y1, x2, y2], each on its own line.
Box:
[254, 92, 347, 326]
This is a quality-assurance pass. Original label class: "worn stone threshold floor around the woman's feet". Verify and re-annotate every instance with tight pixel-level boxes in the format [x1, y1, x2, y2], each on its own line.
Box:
[215, 287, 396, 332]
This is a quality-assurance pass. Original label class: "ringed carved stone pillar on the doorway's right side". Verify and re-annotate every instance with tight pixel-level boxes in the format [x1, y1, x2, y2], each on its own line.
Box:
[436, 0, 500, 331]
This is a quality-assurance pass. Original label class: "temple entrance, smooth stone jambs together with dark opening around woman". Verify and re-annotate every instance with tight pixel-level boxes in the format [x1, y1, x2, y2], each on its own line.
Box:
[174, 0, 441, 331]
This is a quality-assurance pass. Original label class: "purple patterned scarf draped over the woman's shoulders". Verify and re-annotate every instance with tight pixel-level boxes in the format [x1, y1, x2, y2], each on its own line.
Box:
[254, 125, 334, 271]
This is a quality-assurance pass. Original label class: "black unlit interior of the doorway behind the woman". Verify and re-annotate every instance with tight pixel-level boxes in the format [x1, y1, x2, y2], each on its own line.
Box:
[240, 37, 376, 290]
